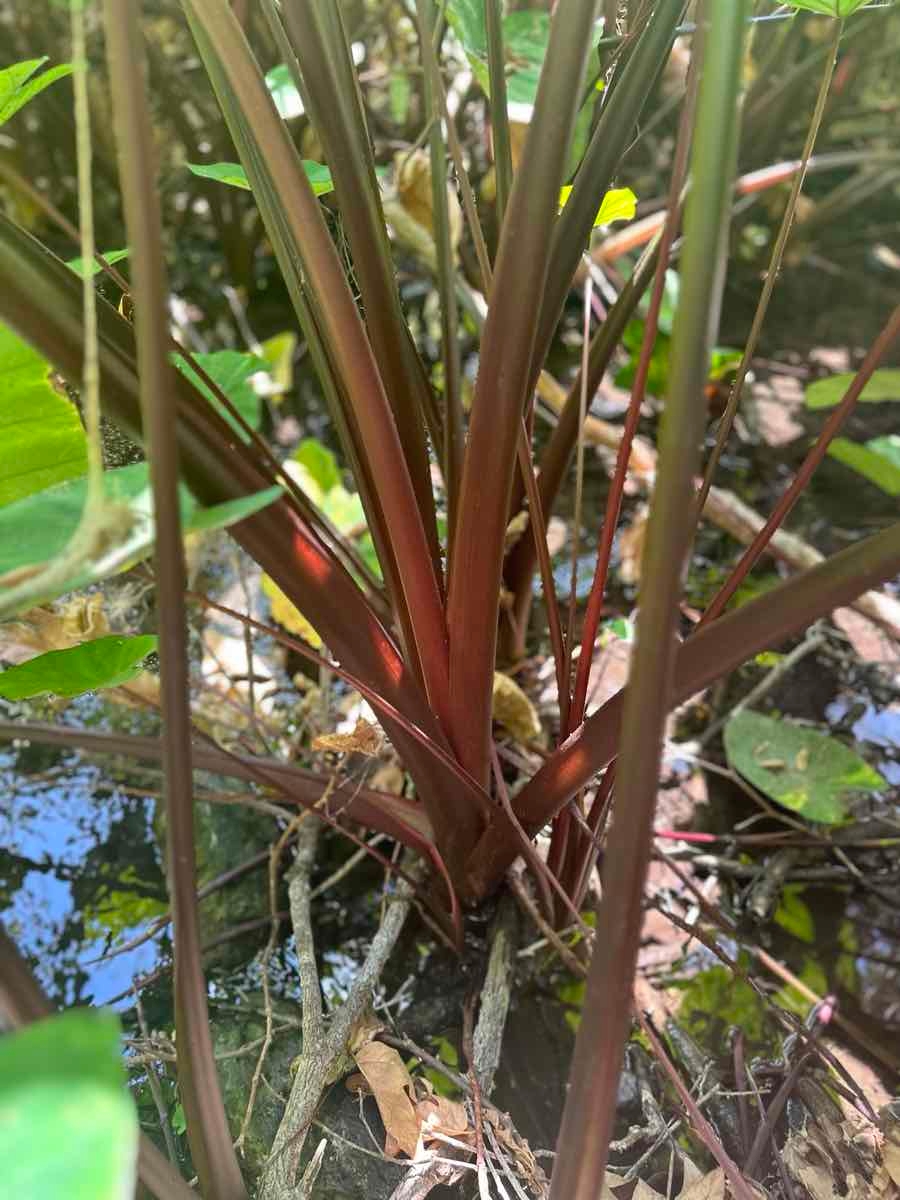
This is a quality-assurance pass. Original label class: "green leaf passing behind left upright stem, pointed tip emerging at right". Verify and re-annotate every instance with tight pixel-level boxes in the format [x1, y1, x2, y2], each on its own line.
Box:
[0, 462, 281, 600]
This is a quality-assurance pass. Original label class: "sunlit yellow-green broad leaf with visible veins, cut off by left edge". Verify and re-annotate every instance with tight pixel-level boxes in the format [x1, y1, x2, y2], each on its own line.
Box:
[0, 325, 88, 505]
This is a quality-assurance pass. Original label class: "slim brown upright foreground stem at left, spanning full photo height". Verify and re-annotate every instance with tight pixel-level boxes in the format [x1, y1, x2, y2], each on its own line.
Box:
[103, 0, 247, 1200]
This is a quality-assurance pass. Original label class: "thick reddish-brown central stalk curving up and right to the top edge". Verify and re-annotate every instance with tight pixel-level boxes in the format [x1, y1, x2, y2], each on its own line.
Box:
[446, 0, 595, 785]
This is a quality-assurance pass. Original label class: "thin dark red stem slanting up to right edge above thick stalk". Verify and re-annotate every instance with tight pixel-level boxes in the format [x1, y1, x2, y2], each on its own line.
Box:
[697, 305, 900, 629]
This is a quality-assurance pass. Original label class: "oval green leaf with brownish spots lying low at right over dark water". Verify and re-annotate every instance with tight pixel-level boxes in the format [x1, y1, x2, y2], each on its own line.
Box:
[725, 712, 887, 824]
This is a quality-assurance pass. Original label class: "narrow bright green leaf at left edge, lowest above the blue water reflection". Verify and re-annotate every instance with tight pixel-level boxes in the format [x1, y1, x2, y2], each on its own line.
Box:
[0, 636, 156, 700]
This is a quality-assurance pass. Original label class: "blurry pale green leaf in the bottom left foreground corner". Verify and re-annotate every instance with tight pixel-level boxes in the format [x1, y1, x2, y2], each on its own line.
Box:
[0, 1009, 138, 1200]
